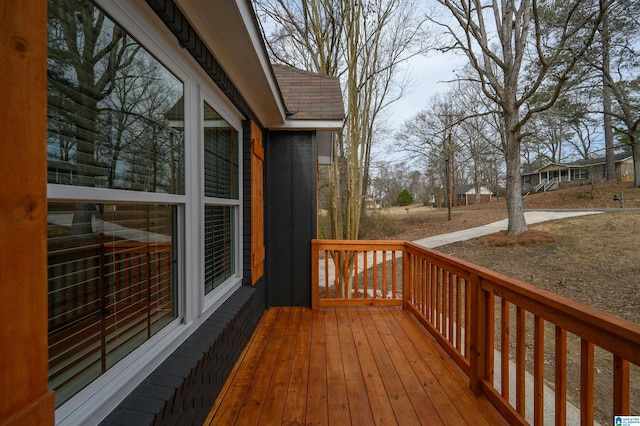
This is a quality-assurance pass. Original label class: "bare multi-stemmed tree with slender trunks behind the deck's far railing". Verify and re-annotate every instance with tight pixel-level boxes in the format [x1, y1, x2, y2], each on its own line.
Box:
[255, 0, 425, 239]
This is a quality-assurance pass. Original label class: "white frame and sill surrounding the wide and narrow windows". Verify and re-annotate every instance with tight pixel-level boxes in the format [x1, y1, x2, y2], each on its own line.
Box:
[47, 0, 244, 425]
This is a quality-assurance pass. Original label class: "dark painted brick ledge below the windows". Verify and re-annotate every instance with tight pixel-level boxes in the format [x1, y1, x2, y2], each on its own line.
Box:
[101, 280, 265, 426]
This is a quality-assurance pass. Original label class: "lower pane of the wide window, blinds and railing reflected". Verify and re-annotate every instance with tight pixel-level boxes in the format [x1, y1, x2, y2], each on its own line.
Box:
[48, 202, 178, 405]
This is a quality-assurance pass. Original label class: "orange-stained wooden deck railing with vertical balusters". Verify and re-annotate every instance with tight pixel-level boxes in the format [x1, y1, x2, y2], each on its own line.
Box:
[312, 240, 640, 424]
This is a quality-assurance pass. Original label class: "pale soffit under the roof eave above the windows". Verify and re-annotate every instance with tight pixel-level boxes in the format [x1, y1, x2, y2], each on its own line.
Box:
[175, 0, 286, 127]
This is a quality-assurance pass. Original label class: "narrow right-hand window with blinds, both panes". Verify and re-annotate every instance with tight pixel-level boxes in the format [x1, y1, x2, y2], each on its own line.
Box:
[203, 102, 239, 294]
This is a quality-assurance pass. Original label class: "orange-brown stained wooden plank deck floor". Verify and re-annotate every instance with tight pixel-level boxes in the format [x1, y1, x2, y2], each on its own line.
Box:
[205, 308, 506, 425]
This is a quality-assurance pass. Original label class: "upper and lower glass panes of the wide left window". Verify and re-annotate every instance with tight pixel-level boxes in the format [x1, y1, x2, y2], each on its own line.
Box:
[47, 1, 185, 406]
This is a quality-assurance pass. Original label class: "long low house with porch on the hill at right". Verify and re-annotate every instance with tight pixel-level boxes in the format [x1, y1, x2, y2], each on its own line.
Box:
[521, 153, 633, 192]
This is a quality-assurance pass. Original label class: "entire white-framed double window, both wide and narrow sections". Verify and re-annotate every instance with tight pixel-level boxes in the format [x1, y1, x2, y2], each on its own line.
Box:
[47, 0, 242, 416]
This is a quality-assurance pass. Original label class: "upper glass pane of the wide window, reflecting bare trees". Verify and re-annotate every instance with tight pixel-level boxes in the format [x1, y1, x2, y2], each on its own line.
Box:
[47, 0, 184, 194]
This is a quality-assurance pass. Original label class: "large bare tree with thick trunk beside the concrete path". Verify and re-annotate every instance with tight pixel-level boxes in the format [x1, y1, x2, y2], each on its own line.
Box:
[437, 0, 601, 235]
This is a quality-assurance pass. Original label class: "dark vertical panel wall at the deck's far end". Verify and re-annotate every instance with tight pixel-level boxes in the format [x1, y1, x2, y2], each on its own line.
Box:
[265, 132, 317, 306]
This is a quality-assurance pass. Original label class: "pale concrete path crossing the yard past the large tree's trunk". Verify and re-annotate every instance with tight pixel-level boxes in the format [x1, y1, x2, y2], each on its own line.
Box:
[414, 210, 602, 248]
